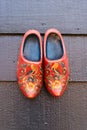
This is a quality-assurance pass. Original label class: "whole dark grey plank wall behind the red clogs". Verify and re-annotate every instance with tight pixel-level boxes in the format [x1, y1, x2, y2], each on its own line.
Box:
[0, 0, 87, 130]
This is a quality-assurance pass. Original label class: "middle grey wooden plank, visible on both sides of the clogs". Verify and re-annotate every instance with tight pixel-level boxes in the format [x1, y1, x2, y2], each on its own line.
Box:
[0, 35, 87, 81]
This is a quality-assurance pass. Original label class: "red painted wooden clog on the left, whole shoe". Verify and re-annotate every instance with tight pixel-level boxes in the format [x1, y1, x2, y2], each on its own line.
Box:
[17, 30, 43, 98]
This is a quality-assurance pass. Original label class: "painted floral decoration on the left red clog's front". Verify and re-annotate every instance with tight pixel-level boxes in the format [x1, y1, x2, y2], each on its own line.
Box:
[18, 63, 43, 96]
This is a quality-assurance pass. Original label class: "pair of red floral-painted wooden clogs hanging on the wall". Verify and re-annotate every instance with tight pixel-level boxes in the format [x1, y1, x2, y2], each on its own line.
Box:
[17, 29, 69, 98]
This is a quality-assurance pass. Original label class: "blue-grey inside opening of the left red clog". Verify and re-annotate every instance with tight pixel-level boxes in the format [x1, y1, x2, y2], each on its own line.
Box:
[23, 34, 41, 61]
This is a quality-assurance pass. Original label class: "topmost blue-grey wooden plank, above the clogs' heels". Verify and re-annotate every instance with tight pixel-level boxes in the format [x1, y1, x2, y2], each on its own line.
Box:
[0, 0, 87, 34]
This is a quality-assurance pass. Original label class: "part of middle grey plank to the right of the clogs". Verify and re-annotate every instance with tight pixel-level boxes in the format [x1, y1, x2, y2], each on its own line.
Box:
[64, 36, 87, 81]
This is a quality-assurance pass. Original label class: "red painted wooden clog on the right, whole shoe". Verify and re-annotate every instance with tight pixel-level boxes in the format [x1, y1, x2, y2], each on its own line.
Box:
[44, 29, 69, 96]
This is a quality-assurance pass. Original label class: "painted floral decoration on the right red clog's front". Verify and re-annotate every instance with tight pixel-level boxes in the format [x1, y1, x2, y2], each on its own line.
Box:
[45, 62, 68, 95]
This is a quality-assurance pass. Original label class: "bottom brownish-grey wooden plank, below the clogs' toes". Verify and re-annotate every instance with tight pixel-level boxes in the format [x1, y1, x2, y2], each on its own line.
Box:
[0, 82, 87, 130]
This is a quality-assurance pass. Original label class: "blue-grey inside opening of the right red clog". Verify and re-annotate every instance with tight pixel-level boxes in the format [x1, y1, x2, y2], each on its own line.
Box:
[46, 33, 64, 60]
